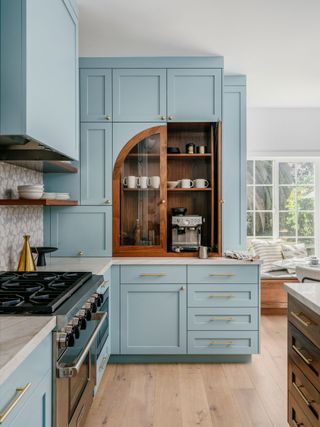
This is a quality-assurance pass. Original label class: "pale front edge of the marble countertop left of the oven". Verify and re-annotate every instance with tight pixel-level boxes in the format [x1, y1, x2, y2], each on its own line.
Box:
[0, 316, 56, 385]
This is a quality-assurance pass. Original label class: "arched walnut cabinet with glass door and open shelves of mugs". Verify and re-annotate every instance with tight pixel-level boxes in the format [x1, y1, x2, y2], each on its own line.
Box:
[112, 122, 222, 256]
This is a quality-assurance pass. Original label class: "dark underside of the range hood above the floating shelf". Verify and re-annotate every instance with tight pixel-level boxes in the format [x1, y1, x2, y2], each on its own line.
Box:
[0, 135, 73, 162]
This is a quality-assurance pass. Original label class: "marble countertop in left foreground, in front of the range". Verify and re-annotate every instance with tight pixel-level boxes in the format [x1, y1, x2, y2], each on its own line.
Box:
[0, 315, 56, 385]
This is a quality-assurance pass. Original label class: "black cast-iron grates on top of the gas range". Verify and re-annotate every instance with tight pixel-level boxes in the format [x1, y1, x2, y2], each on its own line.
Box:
[0, 272, 92, 314]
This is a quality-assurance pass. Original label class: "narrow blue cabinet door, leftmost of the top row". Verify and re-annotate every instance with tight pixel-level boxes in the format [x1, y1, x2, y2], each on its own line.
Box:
[80, 68, 112, 122]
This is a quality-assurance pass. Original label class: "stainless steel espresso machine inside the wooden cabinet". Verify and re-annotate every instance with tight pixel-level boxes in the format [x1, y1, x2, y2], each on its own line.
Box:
[171, 208, 204, 252]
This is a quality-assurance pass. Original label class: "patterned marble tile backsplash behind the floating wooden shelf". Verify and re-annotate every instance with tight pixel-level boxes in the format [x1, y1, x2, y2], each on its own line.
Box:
[0, 162, 43, 271]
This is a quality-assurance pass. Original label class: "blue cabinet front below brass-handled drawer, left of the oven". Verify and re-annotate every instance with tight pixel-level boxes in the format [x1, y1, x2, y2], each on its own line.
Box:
[8, 371, 52, 427]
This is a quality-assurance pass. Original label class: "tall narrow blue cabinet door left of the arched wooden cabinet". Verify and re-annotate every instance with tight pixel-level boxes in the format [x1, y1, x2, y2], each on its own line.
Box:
[80, 123, 112, 205]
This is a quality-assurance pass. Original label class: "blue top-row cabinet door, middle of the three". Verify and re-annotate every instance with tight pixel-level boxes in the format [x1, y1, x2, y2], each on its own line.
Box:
[113, 69, 166, 122]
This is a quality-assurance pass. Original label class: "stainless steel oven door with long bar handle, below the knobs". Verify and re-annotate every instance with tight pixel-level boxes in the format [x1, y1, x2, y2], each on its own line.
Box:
[56, 312, 107, 427]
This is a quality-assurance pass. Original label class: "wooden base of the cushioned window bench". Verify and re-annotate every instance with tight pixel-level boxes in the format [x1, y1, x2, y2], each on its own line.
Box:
[261, 279, 299, 315]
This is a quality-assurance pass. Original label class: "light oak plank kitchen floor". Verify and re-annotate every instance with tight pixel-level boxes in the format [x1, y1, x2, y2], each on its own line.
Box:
[85, 316, 288, 427]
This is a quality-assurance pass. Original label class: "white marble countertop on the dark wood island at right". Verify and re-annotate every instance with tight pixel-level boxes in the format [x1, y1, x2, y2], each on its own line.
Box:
[284, 282, 320, 315]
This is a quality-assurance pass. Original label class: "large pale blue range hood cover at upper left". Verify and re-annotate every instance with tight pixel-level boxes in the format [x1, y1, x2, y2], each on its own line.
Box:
[0, 0, 79, 159]
